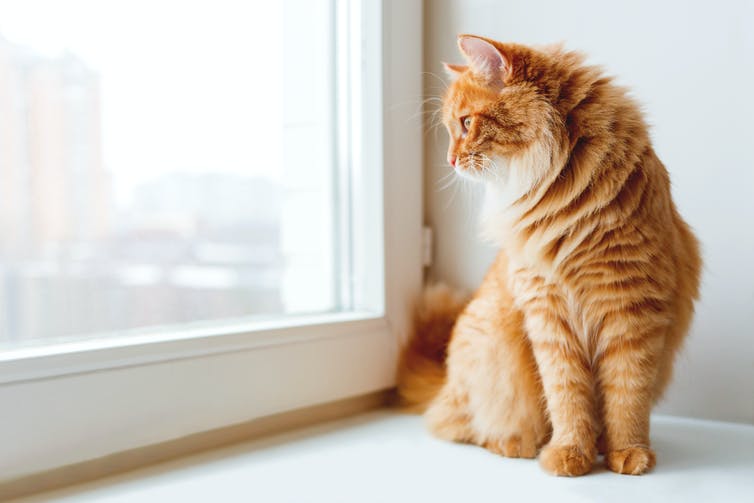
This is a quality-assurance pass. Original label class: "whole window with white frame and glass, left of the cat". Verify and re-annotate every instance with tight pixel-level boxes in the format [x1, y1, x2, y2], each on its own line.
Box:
[0, 0, 422, 478]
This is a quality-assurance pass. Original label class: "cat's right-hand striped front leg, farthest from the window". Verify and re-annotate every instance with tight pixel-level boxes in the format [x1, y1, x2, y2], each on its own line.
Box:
[597, 312, 656, 475]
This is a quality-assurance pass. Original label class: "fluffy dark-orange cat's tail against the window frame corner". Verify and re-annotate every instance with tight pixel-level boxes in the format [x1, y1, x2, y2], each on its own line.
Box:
[398, 284, 468, 412]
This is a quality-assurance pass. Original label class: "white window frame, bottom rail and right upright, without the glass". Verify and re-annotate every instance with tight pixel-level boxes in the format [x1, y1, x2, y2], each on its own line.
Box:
[0, 0, 422, 481]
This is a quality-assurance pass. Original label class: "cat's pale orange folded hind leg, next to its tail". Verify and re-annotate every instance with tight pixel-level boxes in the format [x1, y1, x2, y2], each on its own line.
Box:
[448, 272, 549, 458]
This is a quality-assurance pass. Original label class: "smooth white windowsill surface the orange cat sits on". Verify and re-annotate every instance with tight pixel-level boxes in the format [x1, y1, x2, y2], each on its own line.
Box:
[11, 410, 754, 503]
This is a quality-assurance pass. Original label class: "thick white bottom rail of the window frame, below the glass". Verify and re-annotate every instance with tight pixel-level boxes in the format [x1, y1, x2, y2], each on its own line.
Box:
[0, 317, 399, 483]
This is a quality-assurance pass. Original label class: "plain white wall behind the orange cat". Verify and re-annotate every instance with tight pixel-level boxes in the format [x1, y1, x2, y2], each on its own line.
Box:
[425, 0, 754, 423]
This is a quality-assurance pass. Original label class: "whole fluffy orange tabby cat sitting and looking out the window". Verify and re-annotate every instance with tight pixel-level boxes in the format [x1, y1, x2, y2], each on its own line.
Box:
[399, 35, 701, 476]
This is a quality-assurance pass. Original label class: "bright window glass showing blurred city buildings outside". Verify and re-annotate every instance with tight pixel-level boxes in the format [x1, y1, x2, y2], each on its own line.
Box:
[0, 0, 360, 347]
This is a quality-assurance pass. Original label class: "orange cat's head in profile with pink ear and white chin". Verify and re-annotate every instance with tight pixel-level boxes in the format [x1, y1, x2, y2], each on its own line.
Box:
[443, 35, 563, 196]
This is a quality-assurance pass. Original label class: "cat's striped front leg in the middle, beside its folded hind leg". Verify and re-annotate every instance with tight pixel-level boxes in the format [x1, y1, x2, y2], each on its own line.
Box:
[525, 293, 596, 476]
